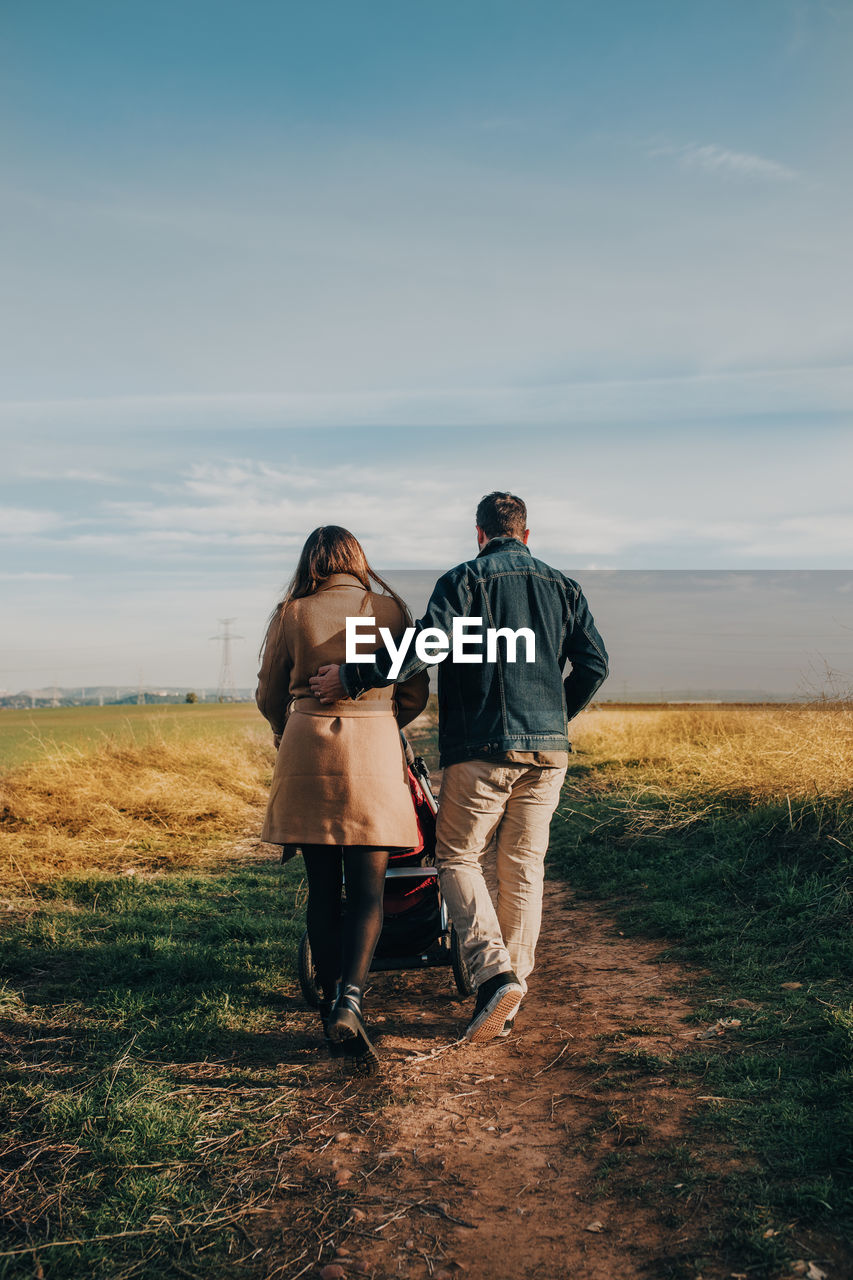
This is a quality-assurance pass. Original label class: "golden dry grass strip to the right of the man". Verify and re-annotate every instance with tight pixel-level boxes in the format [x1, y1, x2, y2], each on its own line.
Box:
[573, 701, 853, 803]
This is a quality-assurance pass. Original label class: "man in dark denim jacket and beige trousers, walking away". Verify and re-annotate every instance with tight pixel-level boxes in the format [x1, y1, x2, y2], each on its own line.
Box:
[310, 493, 607, 1042]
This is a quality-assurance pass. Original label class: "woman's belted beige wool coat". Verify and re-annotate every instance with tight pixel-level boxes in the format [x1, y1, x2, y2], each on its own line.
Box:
[256, 573, 429, 849]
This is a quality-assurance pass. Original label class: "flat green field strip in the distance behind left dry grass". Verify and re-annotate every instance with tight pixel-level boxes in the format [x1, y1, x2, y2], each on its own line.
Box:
[0, 703, 266, 771]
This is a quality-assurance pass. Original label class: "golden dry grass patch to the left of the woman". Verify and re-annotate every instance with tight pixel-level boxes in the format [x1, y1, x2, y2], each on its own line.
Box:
[0, 733, 272, 888]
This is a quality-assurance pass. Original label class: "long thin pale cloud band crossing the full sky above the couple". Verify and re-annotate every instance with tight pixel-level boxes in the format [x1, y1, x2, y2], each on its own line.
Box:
[0, 360, 853, 435]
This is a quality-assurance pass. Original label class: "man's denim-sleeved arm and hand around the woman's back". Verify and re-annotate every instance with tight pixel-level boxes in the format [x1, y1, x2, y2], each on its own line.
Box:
[309, 571, 471, 703]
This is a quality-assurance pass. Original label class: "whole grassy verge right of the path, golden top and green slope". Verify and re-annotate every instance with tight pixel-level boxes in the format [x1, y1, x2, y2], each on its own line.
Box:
[549, 703, 853, 1275]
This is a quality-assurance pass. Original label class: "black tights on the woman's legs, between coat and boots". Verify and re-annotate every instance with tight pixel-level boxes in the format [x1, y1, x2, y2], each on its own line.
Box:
[302, 845, 388, 1000]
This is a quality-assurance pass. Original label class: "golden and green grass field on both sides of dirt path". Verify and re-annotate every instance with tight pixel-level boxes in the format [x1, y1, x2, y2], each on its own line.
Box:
[0, 704, 853, 1280]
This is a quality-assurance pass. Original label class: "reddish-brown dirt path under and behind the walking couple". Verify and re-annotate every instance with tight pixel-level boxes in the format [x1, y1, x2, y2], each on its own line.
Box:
[258, 860, 731, 1280]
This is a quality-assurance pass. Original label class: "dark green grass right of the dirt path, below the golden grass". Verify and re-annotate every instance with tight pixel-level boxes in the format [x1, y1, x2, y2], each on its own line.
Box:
[549, 759, 853, 1275]
